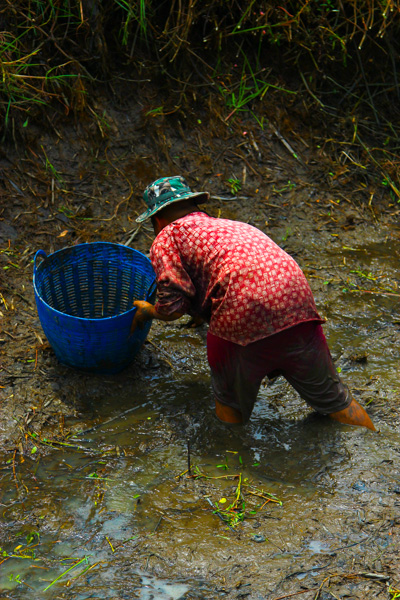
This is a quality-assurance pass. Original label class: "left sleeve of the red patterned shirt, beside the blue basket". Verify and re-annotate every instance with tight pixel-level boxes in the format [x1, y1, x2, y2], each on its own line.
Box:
[150, 232, 196, 315]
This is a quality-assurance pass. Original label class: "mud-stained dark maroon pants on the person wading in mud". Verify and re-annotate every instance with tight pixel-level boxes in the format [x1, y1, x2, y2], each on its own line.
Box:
[207, 321, 351, 422]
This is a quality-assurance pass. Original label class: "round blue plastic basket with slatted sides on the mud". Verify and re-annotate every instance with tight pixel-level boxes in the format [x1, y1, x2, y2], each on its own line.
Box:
[33, 242, 155, 373]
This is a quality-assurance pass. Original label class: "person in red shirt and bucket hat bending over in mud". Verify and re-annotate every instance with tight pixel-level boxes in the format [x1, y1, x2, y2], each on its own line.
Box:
[131, 176, 375, 430]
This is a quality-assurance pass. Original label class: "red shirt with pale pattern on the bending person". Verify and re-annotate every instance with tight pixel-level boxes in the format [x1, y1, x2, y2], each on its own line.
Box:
[150, 212, 323, 346]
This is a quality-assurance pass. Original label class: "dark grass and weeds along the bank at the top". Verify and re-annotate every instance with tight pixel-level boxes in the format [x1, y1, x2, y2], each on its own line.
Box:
[0, 0, 400, 201]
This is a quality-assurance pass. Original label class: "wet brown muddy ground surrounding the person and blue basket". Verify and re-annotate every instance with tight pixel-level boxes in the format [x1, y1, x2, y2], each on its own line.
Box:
[0, 85, 400, 600]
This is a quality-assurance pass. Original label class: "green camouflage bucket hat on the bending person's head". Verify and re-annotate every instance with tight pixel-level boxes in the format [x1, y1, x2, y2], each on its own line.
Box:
[136, 175, 210, 223]
